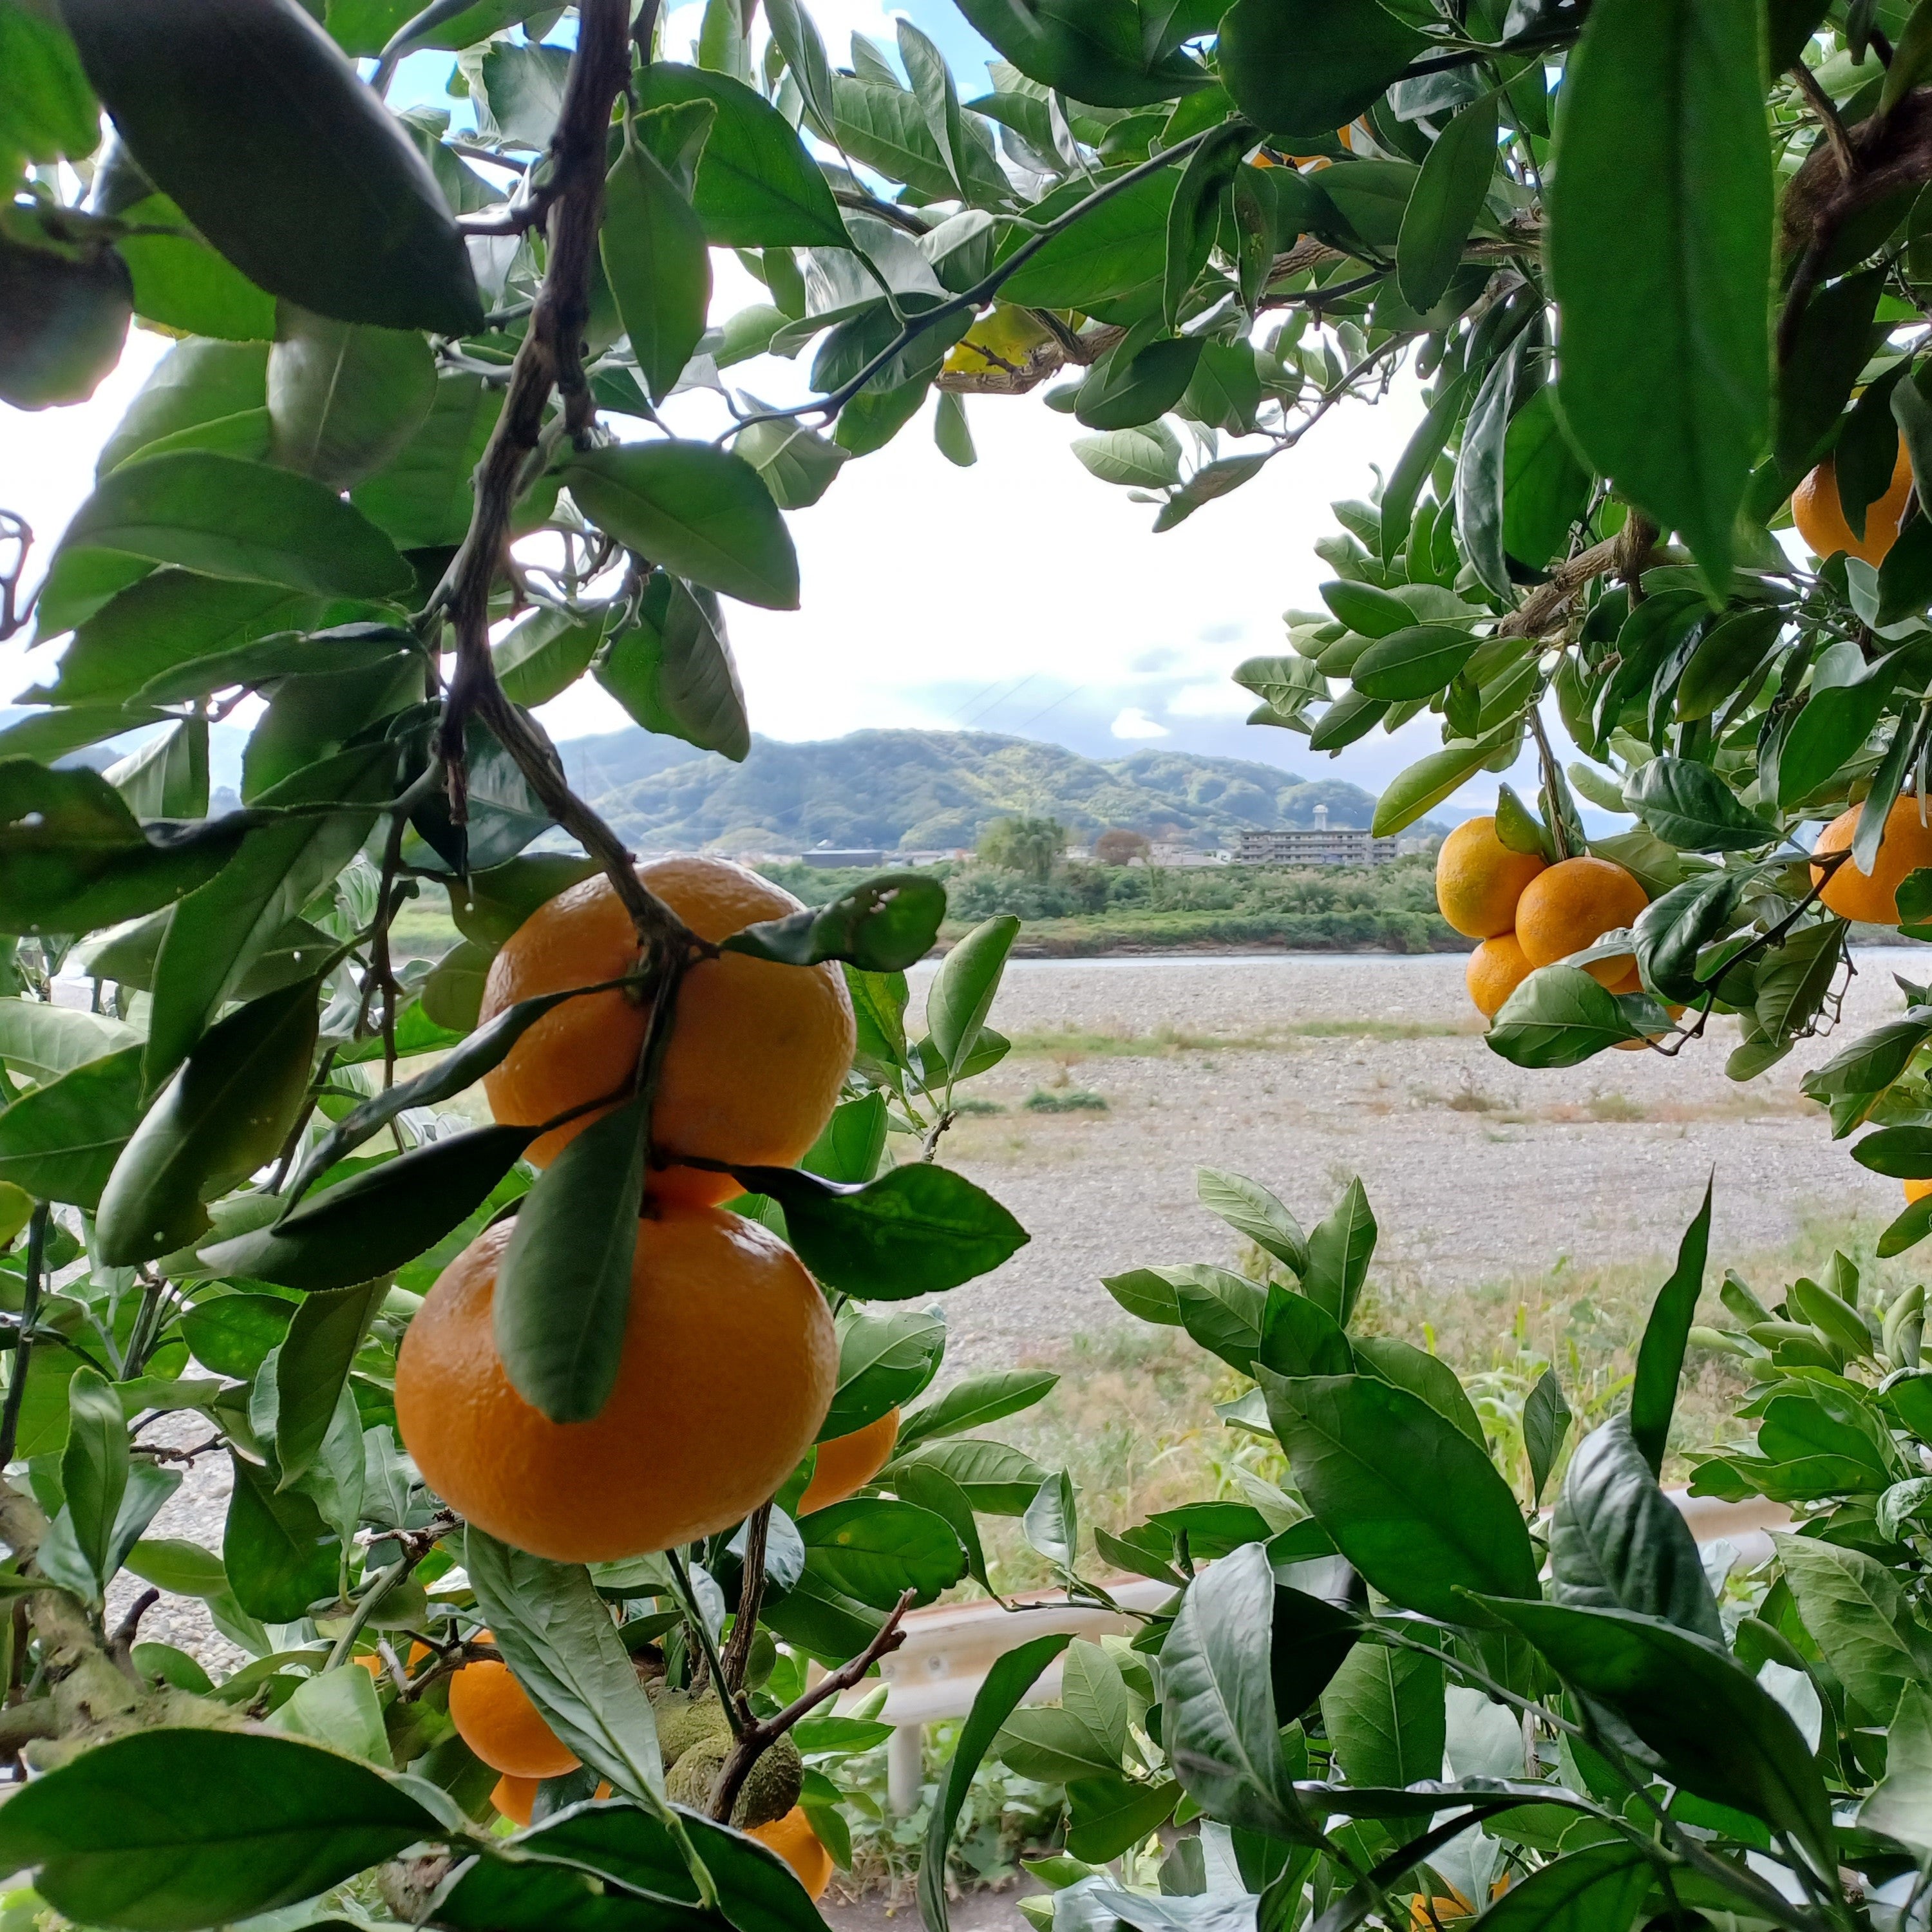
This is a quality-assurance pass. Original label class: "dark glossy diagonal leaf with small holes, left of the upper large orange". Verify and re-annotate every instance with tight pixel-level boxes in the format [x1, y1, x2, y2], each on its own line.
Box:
[95, 980, 321, 1267]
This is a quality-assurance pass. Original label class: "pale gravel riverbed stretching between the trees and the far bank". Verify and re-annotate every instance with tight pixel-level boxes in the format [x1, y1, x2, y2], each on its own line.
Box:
[914, 951, 1932, 1364]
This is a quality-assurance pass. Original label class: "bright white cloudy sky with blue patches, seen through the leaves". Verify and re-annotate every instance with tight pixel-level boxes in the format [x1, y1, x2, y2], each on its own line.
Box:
[0, 0, 1546, 806]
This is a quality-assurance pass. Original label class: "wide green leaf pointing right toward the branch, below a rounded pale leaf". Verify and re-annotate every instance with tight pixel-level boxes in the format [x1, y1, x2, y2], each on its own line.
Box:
[58, 450, 413, 597]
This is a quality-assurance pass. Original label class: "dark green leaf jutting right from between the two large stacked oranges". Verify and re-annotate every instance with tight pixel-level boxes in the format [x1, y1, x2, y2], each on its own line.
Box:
[732, 1163, 1028, 1302]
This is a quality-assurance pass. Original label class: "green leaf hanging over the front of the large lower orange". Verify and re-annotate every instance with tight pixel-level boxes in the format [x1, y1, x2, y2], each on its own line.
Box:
[491, 1099, 649, 1422]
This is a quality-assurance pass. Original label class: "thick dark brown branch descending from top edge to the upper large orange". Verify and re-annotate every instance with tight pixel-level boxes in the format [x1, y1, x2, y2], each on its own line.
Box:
[431, 0, 692, 952]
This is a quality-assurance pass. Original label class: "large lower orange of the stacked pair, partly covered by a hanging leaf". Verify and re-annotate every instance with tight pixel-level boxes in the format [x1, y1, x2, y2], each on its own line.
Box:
[396, 1206, 838, 1569]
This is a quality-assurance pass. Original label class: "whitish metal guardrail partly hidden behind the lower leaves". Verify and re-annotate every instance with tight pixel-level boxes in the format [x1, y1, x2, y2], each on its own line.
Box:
[846, 1490, 1791, 1814]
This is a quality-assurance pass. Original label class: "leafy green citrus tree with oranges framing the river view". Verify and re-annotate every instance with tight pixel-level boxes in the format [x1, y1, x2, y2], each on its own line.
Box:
[15, 0, 1932, 1932]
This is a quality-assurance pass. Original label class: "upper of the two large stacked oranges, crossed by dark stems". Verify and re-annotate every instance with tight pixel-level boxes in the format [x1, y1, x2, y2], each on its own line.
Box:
[479, 858, 852, 1206]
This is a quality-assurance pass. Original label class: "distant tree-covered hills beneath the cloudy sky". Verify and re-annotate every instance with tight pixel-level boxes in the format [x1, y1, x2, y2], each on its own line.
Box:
[558, 730, 1406, 852]
